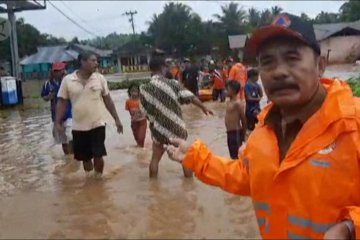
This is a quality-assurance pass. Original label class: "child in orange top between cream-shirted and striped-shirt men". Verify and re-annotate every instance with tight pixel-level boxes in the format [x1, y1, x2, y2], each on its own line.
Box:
[125, 84, 147, 147]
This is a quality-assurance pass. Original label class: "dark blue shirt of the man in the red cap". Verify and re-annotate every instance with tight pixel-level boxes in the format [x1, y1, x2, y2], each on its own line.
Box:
[41, 80, 72, 122]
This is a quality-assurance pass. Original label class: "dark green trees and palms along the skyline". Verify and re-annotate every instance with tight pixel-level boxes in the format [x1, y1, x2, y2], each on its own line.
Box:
[0, 0, 360, 61]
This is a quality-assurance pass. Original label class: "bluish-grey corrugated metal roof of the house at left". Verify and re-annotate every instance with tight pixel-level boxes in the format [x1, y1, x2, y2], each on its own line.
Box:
[20, 45, 78, 65]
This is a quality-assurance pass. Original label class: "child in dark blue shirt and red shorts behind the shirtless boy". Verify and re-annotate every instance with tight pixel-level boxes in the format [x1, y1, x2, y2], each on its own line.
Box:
[245, 69, 263, 131]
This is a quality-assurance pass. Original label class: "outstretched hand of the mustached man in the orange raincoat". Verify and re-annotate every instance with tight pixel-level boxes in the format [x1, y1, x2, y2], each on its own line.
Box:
[164, 138, 191, 163]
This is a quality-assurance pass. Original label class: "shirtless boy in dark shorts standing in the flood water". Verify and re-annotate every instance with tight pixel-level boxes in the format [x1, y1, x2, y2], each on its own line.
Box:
[225, 80, 247, 159]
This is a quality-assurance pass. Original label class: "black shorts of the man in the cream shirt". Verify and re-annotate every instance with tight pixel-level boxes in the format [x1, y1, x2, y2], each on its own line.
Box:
[72, 126, 107, 161]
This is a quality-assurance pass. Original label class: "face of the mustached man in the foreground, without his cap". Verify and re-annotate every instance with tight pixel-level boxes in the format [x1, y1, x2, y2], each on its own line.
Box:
[258, 38, 325, 108]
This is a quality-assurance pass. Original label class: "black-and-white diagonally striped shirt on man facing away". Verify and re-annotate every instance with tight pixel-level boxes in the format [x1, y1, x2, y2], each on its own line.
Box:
[140, 75, 194, 144]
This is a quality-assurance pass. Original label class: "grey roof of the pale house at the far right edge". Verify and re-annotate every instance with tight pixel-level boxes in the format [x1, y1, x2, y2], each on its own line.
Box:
[314, 20, 360, 41]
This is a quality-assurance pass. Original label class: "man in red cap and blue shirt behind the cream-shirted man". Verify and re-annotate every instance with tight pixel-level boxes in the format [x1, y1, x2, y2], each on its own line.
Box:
[41, 62, 72, 155]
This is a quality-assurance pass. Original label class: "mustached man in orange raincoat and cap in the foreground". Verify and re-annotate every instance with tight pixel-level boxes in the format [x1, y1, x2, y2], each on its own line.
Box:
[166, 13, 360, 239]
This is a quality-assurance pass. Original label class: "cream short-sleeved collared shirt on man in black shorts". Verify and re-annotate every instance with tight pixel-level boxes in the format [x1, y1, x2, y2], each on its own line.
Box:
[58, 71, 109, 131]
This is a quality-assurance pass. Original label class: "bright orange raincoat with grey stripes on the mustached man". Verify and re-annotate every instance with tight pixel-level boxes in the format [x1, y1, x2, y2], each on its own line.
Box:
[183, 79, 360, 239]
